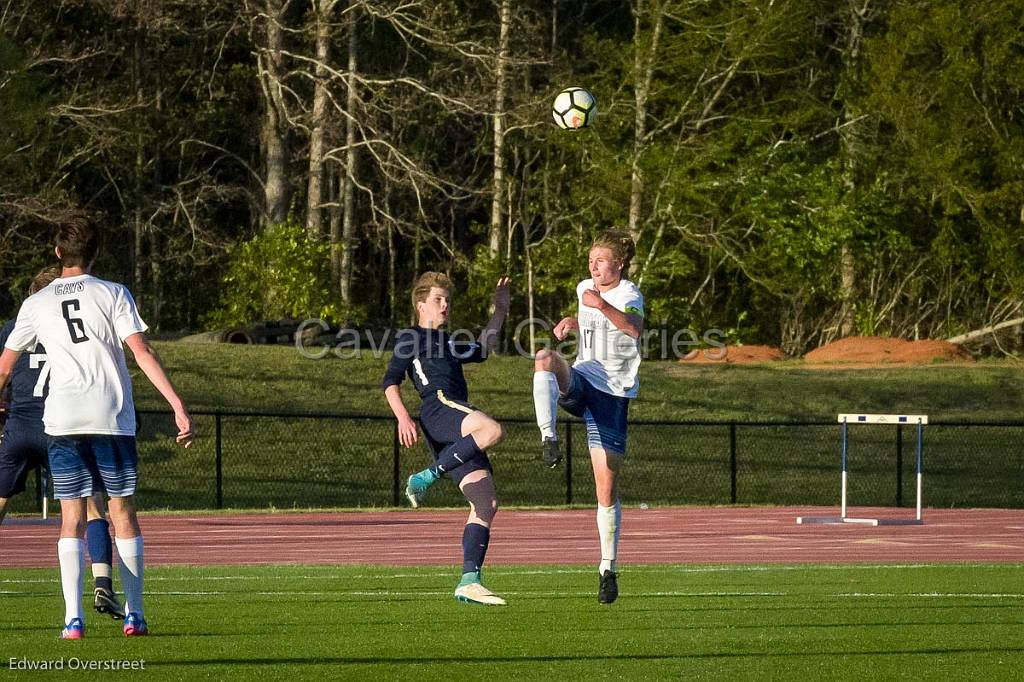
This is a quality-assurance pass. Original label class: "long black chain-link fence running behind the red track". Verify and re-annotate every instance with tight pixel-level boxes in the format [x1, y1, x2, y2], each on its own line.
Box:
[9, 411, 1024, 512]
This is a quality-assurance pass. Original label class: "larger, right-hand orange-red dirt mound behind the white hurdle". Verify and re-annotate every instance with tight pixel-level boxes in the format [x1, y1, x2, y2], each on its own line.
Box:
[804, 336, 974, 365]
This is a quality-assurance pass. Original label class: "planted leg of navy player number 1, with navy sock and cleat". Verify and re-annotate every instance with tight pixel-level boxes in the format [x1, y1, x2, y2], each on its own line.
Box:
[455, 469, 505, 606]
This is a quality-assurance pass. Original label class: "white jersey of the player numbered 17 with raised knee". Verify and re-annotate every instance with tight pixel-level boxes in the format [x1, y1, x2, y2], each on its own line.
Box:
[572, 280, 643, 398]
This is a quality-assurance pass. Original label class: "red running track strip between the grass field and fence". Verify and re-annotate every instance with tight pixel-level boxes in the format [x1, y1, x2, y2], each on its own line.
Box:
[0, 507, 1024, 567]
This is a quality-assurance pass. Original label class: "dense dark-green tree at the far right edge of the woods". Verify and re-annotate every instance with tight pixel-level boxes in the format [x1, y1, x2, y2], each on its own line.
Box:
[865, 0, 1024, 336]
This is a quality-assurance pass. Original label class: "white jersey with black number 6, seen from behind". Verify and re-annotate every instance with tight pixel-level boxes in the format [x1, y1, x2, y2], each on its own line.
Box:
[6, 274, 147, 436]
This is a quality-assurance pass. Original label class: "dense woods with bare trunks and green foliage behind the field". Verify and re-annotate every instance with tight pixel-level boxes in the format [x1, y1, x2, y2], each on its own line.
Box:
[0, 0, 1024, 353]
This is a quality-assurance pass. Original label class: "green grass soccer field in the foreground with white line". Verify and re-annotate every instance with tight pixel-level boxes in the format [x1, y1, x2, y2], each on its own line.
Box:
[0, 564, 1024, 682]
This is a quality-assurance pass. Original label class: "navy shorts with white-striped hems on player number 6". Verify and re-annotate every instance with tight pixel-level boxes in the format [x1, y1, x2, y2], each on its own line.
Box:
[49, 435, 138, 500]
